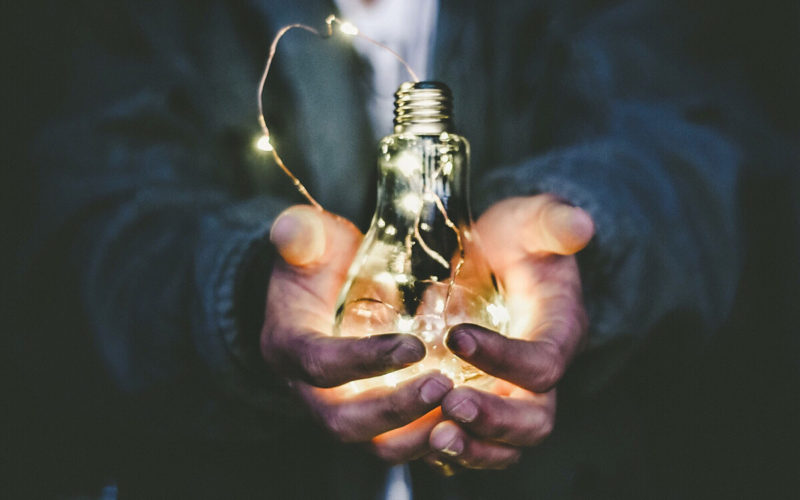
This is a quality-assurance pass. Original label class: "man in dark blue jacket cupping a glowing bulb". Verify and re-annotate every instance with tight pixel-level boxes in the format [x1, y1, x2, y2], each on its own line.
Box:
[14, 0, 756, 498]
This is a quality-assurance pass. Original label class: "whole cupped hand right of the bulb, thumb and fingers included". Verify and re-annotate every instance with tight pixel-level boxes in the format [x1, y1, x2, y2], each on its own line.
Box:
[425, 194, 594, 473]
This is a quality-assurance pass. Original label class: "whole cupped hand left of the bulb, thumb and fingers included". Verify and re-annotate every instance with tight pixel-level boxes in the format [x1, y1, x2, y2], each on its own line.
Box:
[261, 205, 453, 463]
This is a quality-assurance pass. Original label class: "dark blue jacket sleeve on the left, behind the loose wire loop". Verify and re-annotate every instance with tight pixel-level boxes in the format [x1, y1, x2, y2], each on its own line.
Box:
[25, 2, 306, 442]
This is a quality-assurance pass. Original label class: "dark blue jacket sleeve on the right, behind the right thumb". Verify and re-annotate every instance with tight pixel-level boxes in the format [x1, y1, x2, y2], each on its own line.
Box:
[479, 2, 744, 390]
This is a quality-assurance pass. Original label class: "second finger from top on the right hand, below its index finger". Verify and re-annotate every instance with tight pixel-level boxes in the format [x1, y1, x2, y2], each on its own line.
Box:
[442, 387, 555, 446]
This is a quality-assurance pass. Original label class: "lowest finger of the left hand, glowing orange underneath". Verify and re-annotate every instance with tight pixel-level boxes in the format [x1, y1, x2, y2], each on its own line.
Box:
[370, 407, 442, 464]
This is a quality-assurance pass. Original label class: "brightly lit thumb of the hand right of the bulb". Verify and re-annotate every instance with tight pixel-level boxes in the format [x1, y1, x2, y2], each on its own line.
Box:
[478, 194, 594, 262]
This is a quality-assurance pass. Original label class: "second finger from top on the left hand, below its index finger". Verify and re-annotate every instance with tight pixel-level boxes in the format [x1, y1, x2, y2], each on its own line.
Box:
[297, 372, 453, 443]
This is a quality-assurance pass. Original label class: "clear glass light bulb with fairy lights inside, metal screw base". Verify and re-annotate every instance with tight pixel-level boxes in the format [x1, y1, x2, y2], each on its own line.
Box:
[334, 82, 508, 390]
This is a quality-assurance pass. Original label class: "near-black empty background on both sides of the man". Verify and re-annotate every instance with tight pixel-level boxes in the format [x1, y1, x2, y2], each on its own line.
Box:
[0, 0, 800, 498]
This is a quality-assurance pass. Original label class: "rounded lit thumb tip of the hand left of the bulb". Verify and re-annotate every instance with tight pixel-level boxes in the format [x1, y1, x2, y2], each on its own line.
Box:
[269, 205, 326, 267]
